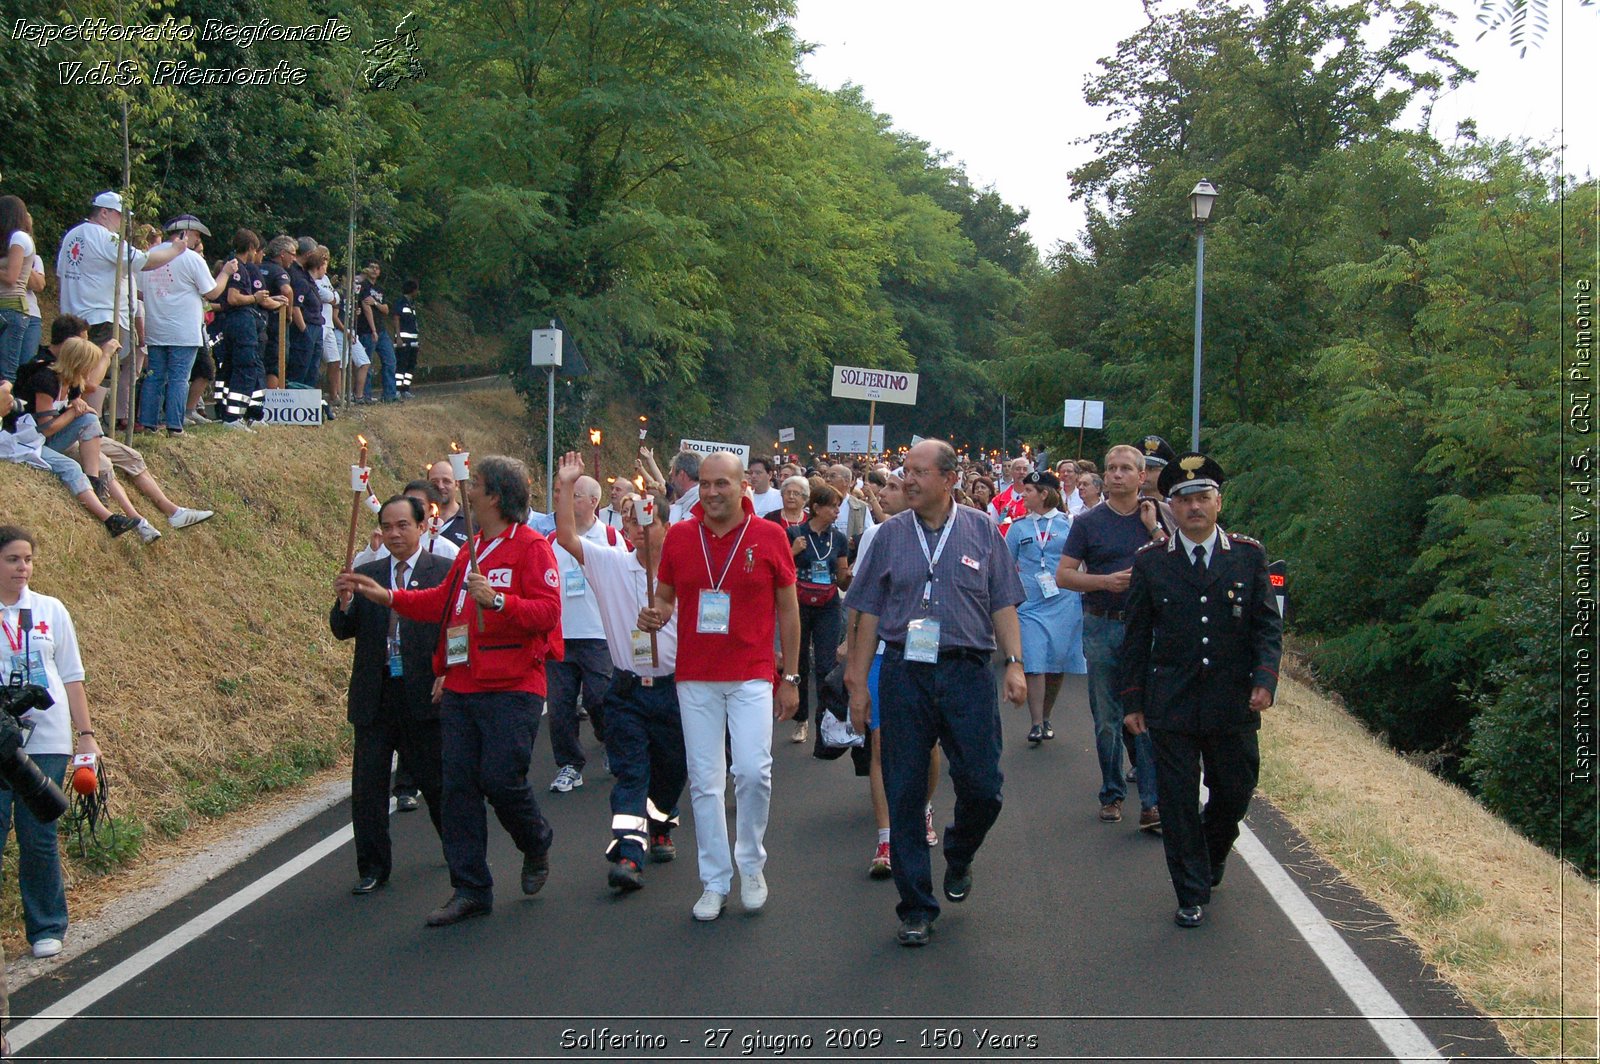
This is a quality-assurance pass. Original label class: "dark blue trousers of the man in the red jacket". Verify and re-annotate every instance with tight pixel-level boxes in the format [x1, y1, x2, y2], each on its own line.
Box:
[438, 691, 552, 904]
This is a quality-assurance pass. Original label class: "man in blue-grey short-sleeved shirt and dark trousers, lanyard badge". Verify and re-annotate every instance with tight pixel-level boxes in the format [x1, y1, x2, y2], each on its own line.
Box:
[845, 440, 1027, 946]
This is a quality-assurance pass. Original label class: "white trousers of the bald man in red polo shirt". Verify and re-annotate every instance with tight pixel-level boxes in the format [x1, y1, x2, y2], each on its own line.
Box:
[678, 680, 773, 894]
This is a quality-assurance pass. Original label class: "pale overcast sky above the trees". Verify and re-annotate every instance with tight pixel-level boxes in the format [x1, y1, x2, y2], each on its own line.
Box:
[795, 0, 1600, 253]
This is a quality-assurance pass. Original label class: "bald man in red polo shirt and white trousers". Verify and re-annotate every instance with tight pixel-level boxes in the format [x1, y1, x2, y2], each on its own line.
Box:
[638, 451, 800, 920]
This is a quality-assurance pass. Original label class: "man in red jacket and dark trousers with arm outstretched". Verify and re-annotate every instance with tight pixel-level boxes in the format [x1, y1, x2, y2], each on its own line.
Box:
[336, 454, 562, 926]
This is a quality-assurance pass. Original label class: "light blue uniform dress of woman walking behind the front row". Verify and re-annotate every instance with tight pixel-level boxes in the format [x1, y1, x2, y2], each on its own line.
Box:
[1005, 510, 1088, 674]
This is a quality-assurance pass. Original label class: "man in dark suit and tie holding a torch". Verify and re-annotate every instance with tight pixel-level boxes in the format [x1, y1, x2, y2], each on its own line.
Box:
[328, 496, 450, 894]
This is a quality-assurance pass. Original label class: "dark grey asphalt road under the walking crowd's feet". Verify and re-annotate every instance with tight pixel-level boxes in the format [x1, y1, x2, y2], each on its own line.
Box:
[11, 678, 1509, 1061]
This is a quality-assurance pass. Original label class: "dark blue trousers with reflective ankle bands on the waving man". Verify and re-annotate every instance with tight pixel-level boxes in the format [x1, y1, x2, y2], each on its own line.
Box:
[605, 672, 688, 864]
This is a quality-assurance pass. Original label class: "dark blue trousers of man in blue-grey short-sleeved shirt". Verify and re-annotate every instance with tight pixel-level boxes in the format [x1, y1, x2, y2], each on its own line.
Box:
[878, 646, 1003, 920]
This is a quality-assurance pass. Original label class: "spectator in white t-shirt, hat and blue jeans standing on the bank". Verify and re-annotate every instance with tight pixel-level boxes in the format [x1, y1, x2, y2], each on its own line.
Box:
[139, 214, 237, 435]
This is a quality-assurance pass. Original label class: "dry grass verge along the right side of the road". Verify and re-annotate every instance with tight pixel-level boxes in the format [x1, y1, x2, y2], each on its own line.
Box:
[1261, 659, 1600, 1061]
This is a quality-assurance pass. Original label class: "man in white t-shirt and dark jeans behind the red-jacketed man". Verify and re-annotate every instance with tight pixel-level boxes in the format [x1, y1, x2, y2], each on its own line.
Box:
[544, 477, 622, 794]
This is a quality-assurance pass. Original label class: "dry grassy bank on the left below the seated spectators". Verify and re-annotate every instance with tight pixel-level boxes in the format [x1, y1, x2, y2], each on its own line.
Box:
[0, 390, 531, 950]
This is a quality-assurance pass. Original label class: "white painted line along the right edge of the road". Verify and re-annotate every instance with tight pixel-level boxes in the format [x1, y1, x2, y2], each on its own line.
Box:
[1235, 824, 1445, 1061]
